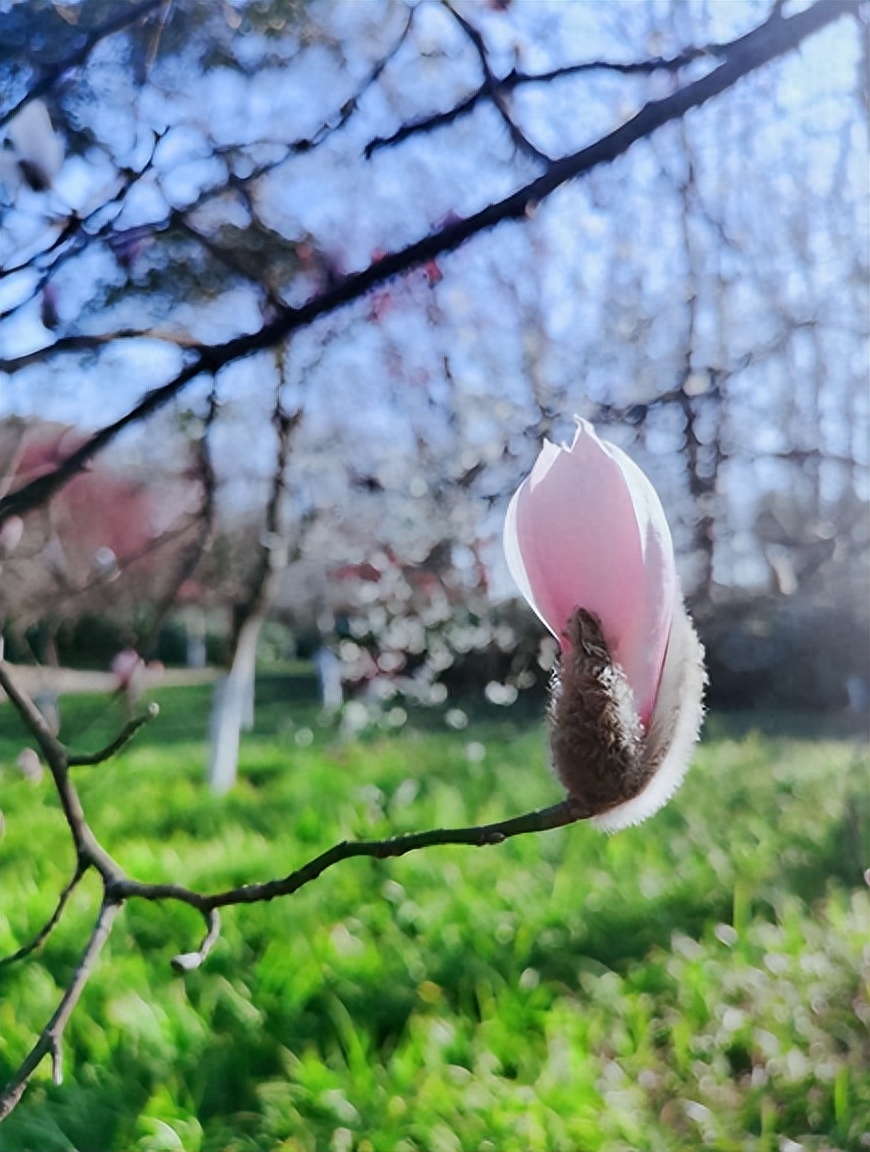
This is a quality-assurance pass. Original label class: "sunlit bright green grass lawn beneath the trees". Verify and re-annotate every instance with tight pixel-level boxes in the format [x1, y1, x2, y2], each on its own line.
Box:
[0, 675, 870, 1152]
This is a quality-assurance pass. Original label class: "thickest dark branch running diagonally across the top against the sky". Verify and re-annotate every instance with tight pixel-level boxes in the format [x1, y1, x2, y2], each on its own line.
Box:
[0, 0, 862, 524]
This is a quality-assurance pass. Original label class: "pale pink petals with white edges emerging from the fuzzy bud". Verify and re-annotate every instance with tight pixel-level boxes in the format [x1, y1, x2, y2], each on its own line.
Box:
[505, 420, 678, 726]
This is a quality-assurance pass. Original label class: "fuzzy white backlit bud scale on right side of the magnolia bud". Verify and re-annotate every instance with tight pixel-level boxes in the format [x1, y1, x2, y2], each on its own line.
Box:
[590, 593, 706, 832]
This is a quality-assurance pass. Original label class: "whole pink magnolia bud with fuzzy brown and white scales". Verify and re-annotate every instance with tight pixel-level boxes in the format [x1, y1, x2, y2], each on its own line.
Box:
[505, 420, 706, 832]
